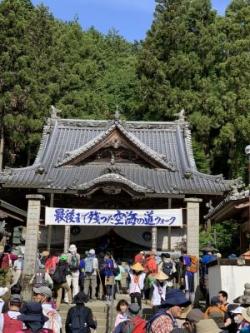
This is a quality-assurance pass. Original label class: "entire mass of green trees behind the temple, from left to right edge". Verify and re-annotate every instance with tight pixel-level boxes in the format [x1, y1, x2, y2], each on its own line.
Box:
[0, 0, 250, 182]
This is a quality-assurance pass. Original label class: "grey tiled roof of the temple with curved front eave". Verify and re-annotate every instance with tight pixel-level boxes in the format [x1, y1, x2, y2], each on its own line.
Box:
[0, 119, 232, 195]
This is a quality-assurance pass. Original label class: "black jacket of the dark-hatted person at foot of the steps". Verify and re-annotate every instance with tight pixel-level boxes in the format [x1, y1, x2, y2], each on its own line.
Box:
[65, 305, 97, 333]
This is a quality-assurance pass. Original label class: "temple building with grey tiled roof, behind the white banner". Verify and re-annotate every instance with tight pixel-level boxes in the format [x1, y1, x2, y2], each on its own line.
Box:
[0, 108, 236, 256]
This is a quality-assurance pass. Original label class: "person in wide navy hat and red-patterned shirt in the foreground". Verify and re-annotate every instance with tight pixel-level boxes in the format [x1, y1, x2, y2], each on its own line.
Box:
[148, 289, 191, 333]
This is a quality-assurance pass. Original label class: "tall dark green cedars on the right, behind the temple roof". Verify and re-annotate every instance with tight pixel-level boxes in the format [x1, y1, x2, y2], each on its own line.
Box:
[137, 0, 250, 177]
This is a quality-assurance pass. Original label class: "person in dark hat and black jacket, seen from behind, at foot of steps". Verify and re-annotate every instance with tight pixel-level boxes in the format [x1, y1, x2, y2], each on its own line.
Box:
[65, 291, 97, 333]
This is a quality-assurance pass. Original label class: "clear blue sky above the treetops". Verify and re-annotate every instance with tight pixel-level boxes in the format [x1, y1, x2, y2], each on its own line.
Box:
[32, 0, 230, 41]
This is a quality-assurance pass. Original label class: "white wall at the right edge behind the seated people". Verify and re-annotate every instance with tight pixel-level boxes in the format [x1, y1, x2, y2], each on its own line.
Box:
[208, 265, 250, 302]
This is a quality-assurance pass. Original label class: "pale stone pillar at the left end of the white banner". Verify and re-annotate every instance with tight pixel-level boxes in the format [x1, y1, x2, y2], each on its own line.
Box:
[22, 194, 44, 301]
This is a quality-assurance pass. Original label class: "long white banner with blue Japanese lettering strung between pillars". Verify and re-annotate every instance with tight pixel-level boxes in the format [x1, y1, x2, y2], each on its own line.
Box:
[45, 207, 183, 227]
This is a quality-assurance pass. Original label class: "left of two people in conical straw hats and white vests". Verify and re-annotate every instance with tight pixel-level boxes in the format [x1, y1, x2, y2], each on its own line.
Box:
[129, 263, 146, 307]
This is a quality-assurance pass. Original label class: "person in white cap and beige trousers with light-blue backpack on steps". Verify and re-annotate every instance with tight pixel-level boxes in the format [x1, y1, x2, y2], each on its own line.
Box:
[83, 249, 98, 300]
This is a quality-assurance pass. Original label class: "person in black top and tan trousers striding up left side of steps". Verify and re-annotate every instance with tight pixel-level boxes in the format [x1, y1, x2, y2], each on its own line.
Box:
[52, 254, 72, 310]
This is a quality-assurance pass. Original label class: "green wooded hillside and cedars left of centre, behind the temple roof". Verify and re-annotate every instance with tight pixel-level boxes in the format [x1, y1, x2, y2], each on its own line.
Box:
[0, 0, 138, 166]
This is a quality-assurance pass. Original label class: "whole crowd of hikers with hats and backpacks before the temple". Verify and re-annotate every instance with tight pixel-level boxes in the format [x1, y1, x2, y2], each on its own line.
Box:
[0, 244, 250, 333]
